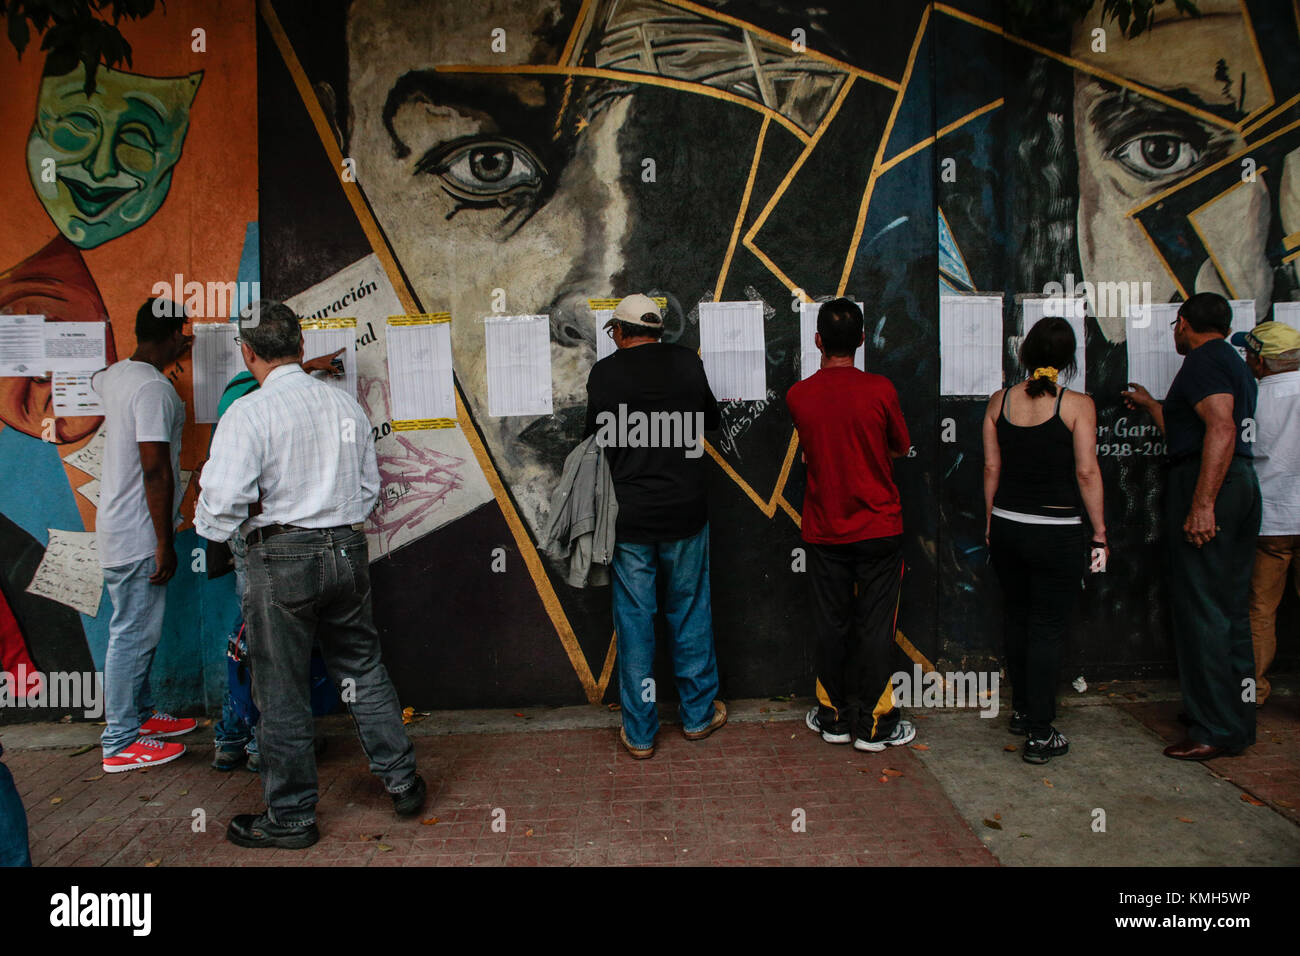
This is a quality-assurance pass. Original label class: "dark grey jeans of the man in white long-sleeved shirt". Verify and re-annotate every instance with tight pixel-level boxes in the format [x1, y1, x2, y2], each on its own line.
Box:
[243, 528, 415, 826]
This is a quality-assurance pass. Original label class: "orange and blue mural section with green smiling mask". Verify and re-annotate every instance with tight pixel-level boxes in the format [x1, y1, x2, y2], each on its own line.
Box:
[0, 3, 256, 712]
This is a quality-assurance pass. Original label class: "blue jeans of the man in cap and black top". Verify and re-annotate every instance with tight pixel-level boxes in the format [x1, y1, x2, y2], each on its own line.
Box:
[614, 524, 718, 748]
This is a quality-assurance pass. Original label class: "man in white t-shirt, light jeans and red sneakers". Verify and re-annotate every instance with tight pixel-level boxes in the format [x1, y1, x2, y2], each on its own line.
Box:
[92, 299, 196, 774]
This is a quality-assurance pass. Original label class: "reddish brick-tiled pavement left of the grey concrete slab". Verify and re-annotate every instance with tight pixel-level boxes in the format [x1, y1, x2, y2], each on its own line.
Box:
[4, 719, 996, 866]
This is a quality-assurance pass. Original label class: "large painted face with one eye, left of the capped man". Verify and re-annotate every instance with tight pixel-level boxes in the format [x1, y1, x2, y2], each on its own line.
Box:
[346, 0, 640, 533]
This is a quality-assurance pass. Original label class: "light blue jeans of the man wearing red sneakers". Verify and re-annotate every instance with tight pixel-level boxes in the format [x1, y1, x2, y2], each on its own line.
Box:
[99, 557, 166, 760]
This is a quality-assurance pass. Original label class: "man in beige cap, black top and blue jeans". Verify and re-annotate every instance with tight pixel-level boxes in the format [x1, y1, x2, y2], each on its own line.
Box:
[585, 295, 727, 760]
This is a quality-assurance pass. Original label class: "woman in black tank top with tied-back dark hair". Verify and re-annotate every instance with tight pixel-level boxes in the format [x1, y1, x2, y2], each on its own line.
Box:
[984, 317, 1108, 763]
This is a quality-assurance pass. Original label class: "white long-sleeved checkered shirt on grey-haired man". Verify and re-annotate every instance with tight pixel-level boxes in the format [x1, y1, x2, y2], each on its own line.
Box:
[194, 364, 380, 541]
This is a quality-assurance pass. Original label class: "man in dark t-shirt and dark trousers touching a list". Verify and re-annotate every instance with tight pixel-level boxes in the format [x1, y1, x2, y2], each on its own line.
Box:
[1125, 293, 1261, 760]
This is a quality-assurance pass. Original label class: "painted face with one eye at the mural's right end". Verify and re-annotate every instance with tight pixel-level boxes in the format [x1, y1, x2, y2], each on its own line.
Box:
[1071, 0, 1295, 341]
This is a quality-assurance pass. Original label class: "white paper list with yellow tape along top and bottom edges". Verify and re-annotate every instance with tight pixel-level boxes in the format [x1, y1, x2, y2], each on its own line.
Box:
[385, 312, 456, 428]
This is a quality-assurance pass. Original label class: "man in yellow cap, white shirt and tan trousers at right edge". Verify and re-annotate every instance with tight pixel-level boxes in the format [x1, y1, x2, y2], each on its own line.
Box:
[1231, 323, 1300, 706]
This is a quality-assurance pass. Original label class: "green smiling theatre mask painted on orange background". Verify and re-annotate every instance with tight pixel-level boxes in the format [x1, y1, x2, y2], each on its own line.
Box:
[27, 65, 203, 248]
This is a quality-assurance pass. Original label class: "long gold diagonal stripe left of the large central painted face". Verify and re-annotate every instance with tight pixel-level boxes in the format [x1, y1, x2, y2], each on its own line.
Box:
[259, 0, 608, 704]
